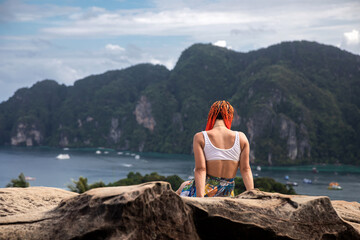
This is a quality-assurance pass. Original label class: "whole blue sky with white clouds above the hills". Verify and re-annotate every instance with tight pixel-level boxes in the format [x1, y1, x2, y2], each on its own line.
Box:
[0, 0, 360, 102]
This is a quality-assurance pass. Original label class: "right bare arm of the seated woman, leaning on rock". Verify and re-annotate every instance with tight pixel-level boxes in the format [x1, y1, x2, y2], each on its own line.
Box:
[239, 133, 254, 191]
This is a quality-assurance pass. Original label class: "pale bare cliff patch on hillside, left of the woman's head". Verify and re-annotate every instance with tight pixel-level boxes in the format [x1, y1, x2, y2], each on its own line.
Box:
[134, 96, 156, 131]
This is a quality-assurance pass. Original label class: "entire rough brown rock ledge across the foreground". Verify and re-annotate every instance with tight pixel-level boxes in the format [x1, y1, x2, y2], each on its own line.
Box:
[0, 182, 360, 240]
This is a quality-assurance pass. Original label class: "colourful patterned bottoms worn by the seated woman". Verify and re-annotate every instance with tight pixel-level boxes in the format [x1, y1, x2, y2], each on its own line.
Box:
[180, 175, 235, 197]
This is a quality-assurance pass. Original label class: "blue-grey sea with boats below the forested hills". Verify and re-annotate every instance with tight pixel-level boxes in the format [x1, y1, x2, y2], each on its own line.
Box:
[0, 146, 360, 202]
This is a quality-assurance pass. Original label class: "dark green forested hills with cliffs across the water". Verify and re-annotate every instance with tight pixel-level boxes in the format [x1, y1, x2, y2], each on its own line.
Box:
[0, 41, 360, 165]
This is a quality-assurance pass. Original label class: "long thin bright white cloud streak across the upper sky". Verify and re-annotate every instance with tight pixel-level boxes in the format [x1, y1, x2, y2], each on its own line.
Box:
[42, 8, 265, 37]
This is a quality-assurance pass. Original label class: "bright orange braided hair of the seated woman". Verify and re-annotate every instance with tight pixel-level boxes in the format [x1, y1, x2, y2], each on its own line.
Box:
[205, 100, 234, 131]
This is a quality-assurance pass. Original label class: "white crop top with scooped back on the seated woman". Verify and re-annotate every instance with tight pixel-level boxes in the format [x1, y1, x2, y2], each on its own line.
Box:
[202, 131, 241, 161]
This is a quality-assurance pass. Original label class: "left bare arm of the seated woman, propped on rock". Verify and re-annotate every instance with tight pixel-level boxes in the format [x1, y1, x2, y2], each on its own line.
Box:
[193, 132, 206, 197]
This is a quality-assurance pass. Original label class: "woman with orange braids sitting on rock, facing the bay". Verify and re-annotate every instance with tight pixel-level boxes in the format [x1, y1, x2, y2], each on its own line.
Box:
[176, 101, 254, 197]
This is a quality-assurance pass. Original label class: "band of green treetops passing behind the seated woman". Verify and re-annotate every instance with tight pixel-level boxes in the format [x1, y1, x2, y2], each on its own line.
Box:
[68, 172, 296, 195]
